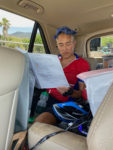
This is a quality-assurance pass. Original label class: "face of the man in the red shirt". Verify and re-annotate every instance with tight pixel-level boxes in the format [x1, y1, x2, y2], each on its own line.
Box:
[56, 33, 75, 58]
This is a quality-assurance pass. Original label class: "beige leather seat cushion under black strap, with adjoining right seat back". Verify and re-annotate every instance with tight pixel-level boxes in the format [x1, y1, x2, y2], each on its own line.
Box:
[28, 84, 113, 150]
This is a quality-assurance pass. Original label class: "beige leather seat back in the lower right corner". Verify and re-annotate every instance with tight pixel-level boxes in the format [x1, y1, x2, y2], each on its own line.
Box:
[87, 83, 113, 150]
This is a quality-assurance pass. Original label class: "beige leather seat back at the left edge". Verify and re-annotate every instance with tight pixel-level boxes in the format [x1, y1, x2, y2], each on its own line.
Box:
[0, 47, 25, 150]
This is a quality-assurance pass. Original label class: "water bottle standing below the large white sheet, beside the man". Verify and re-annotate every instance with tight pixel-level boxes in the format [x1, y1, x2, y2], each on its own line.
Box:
[36, 91, 49, 114]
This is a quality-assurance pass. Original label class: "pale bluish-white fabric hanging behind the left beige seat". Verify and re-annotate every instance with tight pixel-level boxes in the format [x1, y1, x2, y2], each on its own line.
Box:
[15, 48, 35, 132]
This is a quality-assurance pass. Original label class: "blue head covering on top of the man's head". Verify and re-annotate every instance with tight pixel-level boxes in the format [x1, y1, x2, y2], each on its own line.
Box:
[54, 26, 77, 39]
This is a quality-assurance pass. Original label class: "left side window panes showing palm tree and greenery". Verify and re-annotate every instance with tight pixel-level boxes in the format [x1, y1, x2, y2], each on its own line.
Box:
[0, 9, 45, 53]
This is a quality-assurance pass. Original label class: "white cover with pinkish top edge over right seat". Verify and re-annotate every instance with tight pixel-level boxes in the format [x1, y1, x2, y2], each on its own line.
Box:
[77, 68, 113, 116]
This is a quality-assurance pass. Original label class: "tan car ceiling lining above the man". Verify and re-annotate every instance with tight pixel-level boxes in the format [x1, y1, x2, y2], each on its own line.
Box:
[0, 0, 113, 34]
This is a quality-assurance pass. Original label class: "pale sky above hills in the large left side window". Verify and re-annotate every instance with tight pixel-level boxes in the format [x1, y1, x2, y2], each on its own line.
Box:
[0, 9, 34, 27]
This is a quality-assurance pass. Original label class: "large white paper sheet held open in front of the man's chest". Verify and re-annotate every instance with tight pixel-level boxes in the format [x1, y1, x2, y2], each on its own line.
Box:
[29, 53, 69, 89]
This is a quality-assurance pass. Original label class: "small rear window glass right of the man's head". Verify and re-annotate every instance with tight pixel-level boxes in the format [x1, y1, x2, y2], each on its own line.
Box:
[88, 35, 113, 58]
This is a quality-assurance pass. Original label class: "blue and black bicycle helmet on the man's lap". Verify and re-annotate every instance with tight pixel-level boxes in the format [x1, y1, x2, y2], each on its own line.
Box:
[53, 101, 89, 123]
